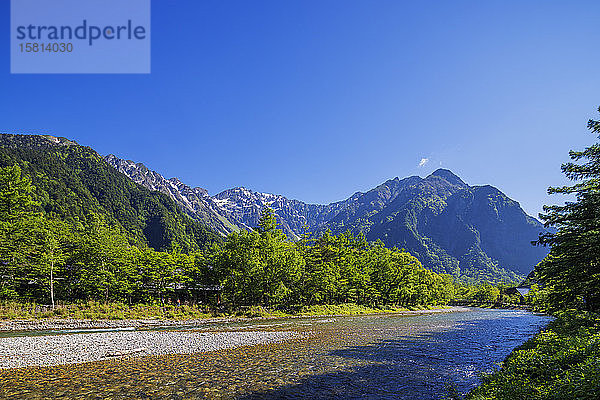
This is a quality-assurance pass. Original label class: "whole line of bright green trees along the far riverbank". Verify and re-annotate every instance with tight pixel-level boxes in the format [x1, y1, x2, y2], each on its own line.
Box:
[0, 165, 455, 308]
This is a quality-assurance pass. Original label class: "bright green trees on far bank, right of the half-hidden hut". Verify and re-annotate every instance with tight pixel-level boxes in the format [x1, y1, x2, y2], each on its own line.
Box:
[212, 217, 454, 309]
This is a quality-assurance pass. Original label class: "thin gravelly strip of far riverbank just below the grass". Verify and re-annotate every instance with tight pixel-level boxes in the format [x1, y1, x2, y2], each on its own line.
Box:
[0, 306, 469, 332]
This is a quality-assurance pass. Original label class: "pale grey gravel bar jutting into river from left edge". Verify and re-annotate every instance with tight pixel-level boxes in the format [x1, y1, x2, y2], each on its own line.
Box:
[0, 331, 299, 369]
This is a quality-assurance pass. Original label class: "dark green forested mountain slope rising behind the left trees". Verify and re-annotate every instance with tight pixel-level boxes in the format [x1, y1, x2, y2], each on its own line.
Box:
[0, 134, 220, 251]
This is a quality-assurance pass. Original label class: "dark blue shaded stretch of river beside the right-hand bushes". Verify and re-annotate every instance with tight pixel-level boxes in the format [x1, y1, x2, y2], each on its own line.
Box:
[240, 317, 552, 400]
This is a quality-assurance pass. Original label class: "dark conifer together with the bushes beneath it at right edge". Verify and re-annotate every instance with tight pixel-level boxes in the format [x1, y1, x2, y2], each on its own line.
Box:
[467, 109, 600, 400]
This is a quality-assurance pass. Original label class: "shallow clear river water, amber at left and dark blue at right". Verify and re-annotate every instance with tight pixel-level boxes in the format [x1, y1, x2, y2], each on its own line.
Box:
[0, 308, 549, 400]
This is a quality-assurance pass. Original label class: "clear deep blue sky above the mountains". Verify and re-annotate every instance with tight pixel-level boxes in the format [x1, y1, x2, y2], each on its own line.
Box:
[0, 0, 600, 219]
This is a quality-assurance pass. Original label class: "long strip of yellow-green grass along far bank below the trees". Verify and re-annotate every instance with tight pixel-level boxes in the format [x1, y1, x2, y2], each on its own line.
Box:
[0, 301, 444, 320]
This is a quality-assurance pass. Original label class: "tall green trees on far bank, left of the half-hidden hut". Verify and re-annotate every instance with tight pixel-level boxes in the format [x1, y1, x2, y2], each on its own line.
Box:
[0, 162, 205, 304]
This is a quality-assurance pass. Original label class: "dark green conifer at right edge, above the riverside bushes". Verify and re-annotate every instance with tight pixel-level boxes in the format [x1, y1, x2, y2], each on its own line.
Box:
[536, 109, 600, 311]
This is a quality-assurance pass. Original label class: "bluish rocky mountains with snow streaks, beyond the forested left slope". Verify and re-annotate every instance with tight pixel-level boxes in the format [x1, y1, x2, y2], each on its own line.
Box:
[106, 155, 547, 281]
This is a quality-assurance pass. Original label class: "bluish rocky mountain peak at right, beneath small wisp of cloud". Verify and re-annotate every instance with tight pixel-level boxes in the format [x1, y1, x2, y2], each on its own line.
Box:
[327, 169, 547, 280]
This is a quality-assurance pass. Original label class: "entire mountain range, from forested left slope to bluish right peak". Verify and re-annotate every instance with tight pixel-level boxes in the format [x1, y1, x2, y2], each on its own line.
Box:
[0, 134, 548, 281]
